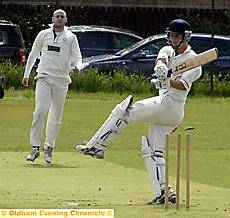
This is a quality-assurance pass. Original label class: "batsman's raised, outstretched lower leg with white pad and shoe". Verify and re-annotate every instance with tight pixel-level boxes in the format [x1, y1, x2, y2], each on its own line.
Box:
[76, 95, 133, 159]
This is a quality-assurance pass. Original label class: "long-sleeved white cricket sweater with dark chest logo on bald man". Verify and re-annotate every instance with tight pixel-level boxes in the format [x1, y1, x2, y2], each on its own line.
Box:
[24, 27, 82, 78]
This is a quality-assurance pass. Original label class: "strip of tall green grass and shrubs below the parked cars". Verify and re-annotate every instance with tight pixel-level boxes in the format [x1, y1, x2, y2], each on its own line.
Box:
[0, 62, 230, 97]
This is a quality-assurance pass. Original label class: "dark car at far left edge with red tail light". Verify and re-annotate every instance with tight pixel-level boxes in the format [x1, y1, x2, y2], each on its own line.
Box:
[0, 20, 26, 65]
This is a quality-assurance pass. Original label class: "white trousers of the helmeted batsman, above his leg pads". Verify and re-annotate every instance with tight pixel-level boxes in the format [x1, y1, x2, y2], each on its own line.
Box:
[127, 96, 184, 146]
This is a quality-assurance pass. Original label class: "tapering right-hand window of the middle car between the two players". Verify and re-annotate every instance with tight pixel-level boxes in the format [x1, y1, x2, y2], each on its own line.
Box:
[110, 33, 139, 51]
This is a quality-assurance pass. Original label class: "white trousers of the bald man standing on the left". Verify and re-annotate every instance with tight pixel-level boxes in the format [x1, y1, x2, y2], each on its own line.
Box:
[30, 74, 71, 148]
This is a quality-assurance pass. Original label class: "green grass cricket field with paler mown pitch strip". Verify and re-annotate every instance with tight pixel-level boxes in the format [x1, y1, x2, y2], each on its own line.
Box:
[0, 92, 230, 218]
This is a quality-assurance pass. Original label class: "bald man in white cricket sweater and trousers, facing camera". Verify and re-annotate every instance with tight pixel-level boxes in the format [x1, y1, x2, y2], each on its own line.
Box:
[22, 9, 82, 163]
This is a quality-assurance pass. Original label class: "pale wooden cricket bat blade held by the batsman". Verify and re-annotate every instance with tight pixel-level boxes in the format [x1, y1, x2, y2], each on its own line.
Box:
[171, 48, 218, 75]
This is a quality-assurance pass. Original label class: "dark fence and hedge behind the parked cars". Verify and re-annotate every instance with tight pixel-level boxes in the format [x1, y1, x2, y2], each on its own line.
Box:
[0, 0, 230, 47]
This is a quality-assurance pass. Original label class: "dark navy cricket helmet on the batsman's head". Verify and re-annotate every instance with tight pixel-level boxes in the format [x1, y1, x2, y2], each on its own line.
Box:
[166, 19, 192, 42]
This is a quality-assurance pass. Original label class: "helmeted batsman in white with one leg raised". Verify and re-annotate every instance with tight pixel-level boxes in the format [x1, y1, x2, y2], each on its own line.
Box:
[76, 19, 202, 205]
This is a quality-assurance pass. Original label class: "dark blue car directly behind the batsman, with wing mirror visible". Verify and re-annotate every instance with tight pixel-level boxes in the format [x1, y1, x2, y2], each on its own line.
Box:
[83, 33, 230, 76]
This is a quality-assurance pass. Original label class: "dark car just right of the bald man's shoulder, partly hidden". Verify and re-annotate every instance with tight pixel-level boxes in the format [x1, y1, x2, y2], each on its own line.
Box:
[69, 25, 143, 57]
